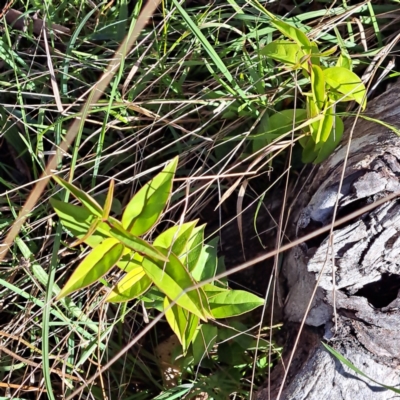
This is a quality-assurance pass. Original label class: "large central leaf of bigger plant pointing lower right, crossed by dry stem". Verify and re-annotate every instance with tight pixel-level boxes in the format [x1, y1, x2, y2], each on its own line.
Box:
[142, 249, 208, 321]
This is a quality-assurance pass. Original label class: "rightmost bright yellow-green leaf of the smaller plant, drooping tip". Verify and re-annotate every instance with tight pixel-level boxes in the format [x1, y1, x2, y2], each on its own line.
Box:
[323, 67, 366, 109]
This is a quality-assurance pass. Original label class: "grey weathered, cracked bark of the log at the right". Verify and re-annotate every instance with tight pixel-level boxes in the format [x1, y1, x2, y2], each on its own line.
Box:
[257, 83, 400, 400]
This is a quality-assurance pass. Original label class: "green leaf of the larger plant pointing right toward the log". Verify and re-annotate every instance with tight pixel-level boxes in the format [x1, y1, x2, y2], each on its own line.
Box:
[208, 290, 264, 318]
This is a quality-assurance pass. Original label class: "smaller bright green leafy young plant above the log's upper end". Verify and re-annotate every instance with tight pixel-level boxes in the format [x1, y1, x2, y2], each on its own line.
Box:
[253, 8, 366, 163]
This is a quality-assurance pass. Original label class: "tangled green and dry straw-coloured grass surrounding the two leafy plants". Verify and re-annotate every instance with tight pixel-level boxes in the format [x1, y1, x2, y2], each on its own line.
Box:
[0, 0, 398, 399]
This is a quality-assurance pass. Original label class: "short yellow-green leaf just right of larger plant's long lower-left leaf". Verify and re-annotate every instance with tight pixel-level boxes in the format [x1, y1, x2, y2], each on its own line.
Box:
[106, 267, 152, 303]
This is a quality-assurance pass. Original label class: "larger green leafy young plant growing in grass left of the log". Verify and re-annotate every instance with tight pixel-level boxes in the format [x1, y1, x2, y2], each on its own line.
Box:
[50, 158, 264, 352]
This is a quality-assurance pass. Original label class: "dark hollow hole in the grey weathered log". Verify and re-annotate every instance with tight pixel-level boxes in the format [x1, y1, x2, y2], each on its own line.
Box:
[355, 274, 400, 308]
